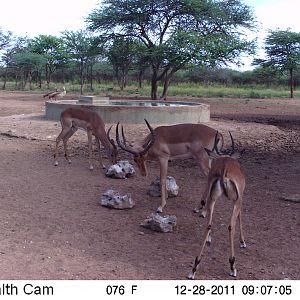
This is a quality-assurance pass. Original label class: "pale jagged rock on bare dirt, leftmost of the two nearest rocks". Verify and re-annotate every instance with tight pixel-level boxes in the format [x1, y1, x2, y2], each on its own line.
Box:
[100, 190, 135, 209]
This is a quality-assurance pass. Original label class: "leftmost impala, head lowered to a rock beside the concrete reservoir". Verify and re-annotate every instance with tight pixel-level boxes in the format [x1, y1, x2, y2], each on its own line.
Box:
[54, 107, 118, 170]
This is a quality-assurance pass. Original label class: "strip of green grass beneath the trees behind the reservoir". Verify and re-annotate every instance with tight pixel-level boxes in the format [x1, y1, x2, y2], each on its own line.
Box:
[0, 82, 300, 99]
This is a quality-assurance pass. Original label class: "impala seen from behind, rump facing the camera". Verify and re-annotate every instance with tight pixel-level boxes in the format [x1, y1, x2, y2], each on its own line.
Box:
[188, 132, 246, 279]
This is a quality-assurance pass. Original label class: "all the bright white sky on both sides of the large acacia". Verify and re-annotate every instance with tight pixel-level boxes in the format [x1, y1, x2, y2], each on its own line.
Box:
[0, 0, 300, 69]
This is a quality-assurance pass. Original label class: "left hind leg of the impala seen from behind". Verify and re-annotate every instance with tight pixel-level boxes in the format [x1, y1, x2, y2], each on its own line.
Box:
[188, 198, 216, 279]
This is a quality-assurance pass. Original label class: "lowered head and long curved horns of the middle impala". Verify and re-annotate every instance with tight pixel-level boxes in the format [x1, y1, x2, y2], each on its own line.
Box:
[116, 119, 155, 176]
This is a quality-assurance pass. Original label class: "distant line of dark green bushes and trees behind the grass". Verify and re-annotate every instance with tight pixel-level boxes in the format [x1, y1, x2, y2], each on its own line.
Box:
[0, 61, 300, 91]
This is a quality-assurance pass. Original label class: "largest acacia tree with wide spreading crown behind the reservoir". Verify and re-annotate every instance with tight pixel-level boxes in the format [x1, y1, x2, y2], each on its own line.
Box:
[87, 0, 254, 99]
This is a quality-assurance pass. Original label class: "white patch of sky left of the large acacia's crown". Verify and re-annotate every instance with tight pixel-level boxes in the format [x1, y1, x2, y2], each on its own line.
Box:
[0, 0, 100, 37]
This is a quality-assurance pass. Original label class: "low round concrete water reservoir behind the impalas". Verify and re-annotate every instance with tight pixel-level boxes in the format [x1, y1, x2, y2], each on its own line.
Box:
[46, 96, 210, 124]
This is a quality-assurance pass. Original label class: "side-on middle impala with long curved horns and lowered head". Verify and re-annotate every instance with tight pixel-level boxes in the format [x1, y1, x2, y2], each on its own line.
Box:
[116, 120, 223, 212]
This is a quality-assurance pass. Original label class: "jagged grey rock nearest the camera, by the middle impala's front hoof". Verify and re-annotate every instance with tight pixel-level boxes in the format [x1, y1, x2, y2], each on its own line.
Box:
[140, 214, 177, 232]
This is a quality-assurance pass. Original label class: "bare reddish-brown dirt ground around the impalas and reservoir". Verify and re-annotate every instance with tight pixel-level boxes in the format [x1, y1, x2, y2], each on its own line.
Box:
[0, 92, 300, 280]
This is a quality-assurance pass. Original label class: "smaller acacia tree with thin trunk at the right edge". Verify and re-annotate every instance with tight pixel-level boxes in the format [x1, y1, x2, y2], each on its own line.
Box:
[253, 30, 300, 98]
